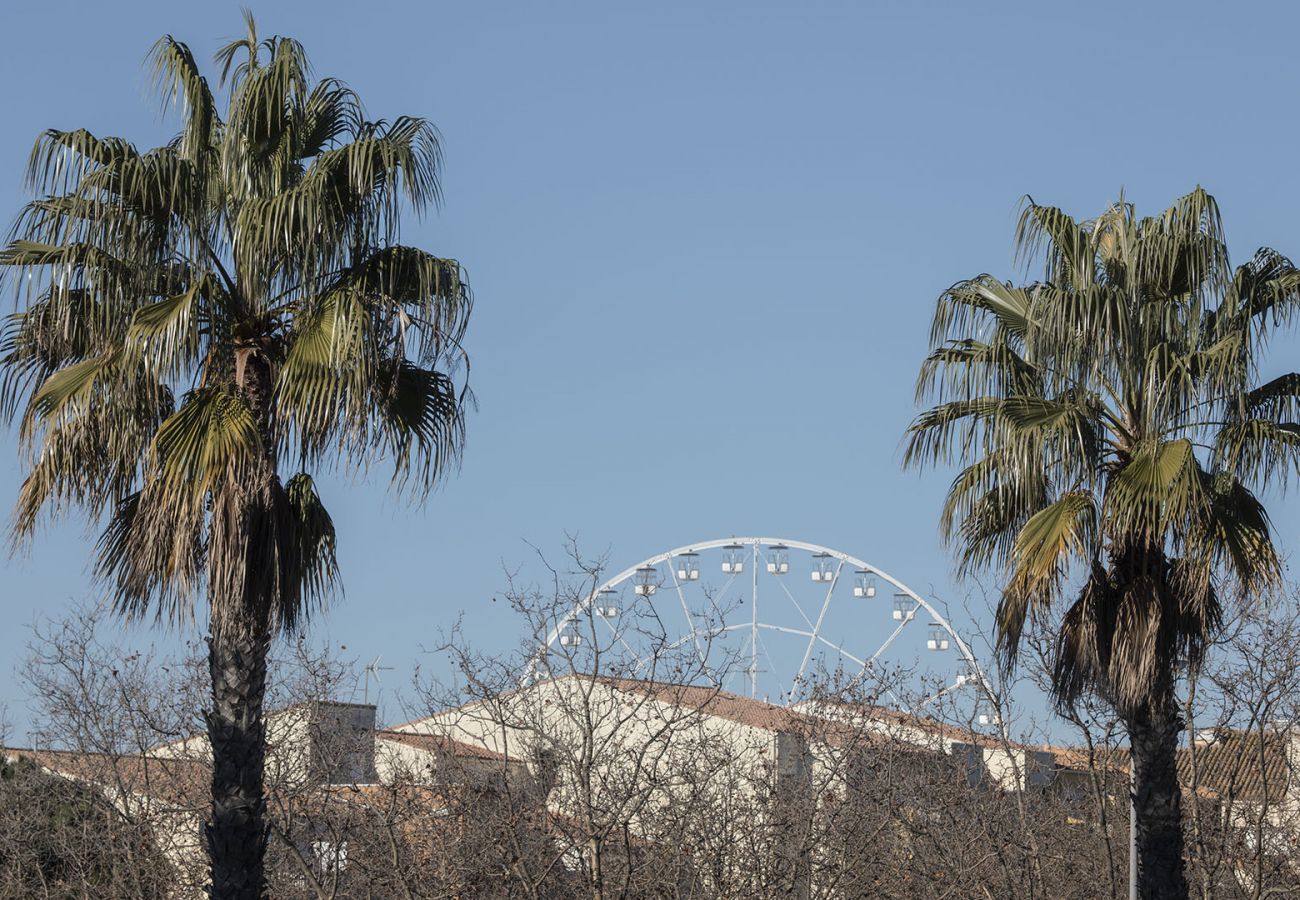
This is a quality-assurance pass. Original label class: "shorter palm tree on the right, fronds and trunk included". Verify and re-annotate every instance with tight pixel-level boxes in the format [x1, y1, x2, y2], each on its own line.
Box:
[905, 189, 1300, 897]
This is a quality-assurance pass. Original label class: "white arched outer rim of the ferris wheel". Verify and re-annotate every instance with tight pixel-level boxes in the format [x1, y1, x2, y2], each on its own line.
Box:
[525, 536, 993, 697]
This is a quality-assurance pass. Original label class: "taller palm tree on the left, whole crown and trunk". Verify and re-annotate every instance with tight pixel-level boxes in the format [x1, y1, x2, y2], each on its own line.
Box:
[0, 14, 469, 897]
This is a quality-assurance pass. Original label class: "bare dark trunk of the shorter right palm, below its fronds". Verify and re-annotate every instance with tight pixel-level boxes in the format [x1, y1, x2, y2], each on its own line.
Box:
[1126, 705, 1188, 900]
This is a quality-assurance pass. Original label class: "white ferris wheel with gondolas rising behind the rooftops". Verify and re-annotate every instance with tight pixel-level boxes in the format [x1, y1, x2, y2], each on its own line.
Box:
[529, 537, 995, 724]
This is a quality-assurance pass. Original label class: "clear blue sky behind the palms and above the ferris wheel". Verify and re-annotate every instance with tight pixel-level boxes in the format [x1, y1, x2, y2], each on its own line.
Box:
[0, 0, 1300, 738]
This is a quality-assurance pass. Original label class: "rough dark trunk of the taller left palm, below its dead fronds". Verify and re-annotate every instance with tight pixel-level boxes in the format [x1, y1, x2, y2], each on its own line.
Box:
[207, 629, 270, 900]
